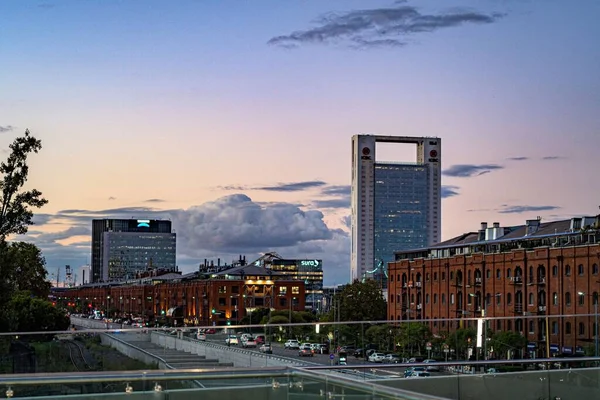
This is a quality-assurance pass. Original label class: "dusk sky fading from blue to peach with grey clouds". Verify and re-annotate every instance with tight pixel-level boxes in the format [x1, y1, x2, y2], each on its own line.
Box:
[0, 0, 600, 285]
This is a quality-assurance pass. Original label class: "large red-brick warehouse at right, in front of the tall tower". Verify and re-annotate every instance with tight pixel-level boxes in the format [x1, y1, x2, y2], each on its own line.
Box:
[388, 216, 600, 356]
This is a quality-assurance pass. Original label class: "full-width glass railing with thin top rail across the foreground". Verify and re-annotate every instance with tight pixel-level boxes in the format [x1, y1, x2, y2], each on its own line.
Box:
[0, 315, 600, 400]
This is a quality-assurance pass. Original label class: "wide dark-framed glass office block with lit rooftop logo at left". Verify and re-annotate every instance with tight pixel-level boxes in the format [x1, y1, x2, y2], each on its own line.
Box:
[91, 219, 176, 282]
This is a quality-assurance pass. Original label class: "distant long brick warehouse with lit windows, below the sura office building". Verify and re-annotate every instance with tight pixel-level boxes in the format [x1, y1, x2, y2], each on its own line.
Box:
[54, 265, 305, 326]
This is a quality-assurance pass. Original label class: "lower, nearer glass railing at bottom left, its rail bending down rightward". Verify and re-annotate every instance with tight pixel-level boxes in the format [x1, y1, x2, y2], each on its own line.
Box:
[0, 368, 450, 400]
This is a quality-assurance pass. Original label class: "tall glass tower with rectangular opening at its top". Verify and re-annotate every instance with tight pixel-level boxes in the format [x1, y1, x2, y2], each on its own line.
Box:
[350, 135, 442, 287]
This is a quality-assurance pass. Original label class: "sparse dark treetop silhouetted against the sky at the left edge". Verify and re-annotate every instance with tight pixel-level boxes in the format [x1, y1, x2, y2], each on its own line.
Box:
[0, 130, 48, 239]
